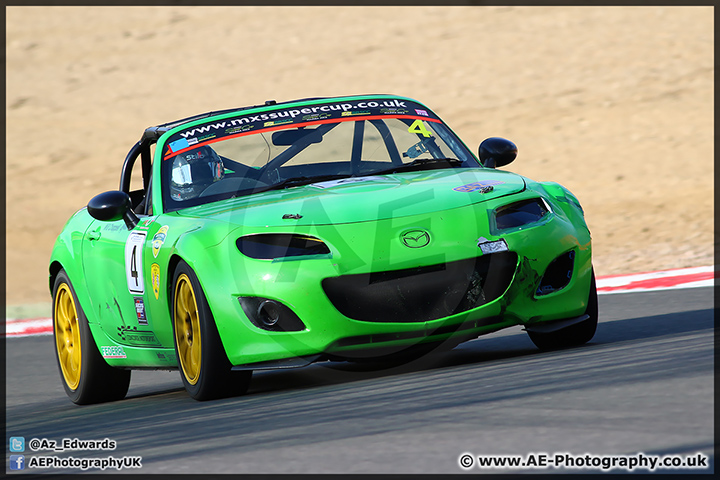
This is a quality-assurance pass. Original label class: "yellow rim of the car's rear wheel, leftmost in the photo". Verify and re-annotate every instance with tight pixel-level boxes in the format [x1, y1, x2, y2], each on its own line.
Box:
[54, 283, 82, 390]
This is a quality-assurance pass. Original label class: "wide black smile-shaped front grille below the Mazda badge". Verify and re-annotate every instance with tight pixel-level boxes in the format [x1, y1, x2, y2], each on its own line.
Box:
[322, 252, 517, 323]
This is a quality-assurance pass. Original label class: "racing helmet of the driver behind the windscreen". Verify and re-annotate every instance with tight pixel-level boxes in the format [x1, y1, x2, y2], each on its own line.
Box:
[170, 145, 225, 201]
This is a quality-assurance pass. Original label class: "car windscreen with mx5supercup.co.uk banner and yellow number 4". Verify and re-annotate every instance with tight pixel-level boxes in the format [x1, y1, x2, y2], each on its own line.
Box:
[161, 98, 480, 211]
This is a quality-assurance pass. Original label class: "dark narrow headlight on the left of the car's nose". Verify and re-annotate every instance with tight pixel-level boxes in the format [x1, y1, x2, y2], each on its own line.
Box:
[236, 233, 330, 260]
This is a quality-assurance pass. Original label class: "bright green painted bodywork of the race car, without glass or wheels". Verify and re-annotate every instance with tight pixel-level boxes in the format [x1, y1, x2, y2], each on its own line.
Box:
[50, 97, 592, 368]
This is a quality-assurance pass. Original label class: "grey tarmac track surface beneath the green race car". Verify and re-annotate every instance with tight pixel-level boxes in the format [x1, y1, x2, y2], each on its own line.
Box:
[6, 288, 714, 474]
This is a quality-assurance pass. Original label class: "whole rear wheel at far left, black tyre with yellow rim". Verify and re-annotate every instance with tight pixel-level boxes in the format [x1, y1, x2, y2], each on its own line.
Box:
[53, 270, 130, 405]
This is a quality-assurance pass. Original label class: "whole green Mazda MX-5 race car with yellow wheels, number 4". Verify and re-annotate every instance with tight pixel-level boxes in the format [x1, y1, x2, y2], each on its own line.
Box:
[49, 95, 598, 404]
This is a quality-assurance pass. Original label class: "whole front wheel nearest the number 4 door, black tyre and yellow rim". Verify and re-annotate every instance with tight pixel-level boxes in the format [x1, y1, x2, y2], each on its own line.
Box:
[172, 261, 252, 400]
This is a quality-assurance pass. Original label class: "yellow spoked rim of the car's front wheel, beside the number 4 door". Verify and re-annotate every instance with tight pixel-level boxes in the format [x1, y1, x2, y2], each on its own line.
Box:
[175, 273, 202, 385]
